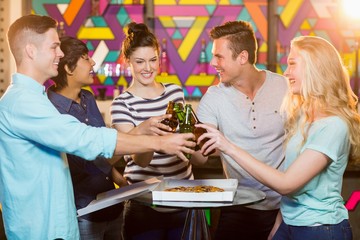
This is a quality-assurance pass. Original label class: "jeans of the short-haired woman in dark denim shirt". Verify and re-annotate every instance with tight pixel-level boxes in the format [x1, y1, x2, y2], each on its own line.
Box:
[78, 214, 123, 240]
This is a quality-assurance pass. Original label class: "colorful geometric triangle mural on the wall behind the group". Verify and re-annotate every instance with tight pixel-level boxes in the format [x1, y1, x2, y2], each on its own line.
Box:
[32, 0, 360, 98]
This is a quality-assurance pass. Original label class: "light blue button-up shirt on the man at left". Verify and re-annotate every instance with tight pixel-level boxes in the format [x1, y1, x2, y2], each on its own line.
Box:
[0, 73, 117, 240]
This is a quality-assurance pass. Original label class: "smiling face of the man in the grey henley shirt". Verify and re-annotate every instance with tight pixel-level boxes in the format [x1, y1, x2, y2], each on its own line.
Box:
[210, 38, 241, 83]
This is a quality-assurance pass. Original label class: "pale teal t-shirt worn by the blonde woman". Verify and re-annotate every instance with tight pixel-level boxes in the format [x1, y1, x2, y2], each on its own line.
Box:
[281, 116, 350, 226]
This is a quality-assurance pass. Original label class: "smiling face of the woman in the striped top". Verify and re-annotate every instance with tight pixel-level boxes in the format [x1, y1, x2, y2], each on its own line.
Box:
[127, 47, 159, 86]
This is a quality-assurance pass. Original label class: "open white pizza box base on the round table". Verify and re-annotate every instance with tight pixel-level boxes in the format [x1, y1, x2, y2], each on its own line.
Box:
[152, 179, 238, 202]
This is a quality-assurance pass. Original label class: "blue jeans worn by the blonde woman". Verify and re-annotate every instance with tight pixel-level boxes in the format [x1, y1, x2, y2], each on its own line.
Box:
[273, 219, 353, 240]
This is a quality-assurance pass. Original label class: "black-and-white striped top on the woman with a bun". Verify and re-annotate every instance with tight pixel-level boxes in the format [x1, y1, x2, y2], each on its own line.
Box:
[110, 84, 193, 184]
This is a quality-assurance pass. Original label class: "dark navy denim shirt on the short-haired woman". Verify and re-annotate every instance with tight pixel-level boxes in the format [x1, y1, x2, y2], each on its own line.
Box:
[48, 89, 122, 222]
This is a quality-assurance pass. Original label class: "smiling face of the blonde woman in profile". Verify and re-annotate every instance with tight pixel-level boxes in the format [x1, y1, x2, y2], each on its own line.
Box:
[284, 47, 304, 95]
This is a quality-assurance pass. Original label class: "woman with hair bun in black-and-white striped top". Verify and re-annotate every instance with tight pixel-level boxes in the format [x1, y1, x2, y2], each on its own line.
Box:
[111, 22, 193, 240]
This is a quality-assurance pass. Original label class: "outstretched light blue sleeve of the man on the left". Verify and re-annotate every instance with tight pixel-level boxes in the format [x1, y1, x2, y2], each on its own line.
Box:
[9, 95, 117, 160]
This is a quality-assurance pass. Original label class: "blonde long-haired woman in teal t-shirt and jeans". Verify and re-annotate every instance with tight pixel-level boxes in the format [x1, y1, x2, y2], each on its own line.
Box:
[198, 36, 360, 240]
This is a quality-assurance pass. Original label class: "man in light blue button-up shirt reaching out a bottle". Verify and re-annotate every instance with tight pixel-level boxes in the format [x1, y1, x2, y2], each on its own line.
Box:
[0, 15, 195, 239]
